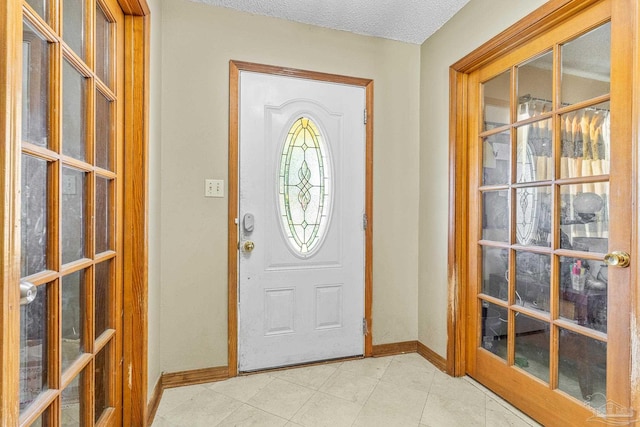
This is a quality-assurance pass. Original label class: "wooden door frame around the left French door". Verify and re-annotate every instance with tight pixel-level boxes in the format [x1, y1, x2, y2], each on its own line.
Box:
[0, 0, 150, 426]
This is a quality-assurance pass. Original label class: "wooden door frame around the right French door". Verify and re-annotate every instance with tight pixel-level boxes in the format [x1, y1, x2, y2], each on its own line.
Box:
[447, 0, 640, 418]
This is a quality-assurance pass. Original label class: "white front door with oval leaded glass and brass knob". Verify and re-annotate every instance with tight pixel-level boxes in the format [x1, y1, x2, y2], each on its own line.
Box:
[238, 71, 365, 371]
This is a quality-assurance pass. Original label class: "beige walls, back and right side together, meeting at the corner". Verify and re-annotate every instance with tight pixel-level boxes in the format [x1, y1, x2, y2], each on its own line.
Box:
[149, 0, 556, 378]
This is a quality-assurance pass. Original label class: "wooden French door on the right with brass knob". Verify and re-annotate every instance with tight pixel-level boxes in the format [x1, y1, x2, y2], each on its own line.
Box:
[466, 0, 635, 426]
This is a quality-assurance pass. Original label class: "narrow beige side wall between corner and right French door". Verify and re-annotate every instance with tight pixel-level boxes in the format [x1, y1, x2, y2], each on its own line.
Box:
[418, 0, 545, 357]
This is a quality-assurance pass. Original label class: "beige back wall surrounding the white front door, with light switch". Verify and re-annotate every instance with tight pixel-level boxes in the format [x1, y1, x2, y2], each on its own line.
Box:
[149, 0, 420, 374]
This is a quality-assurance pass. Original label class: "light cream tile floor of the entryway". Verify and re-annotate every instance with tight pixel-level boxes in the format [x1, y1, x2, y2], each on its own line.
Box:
[153, 353, 538, 427]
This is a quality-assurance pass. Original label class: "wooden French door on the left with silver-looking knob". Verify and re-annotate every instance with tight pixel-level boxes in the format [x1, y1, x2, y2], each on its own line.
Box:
[16, 0, 124, 426]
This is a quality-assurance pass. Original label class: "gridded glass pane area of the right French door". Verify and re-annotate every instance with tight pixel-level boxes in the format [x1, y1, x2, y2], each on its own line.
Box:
[474, 16, 611, 409]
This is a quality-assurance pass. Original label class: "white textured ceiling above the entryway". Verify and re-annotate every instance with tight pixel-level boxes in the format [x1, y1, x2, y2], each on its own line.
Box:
[193, 0, 469, 44]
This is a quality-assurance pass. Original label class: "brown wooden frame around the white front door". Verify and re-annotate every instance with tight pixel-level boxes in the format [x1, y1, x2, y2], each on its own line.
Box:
[227, 60, 373, 377]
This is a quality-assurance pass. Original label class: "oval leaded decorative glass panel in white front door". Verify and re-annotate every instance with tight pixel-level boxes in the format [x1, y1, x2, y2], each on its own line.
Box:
[279, 117, 331, 257]
